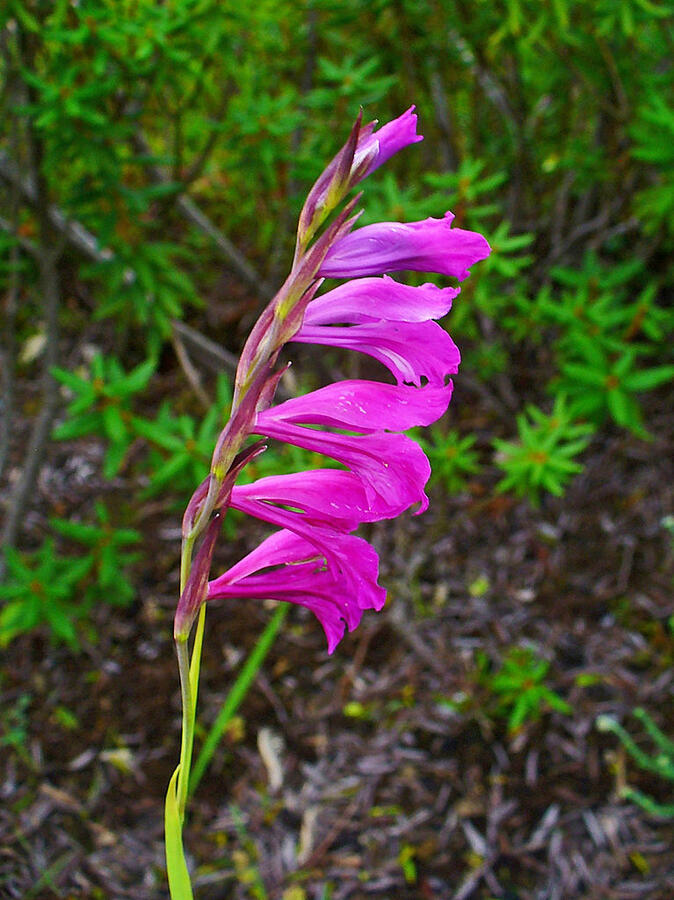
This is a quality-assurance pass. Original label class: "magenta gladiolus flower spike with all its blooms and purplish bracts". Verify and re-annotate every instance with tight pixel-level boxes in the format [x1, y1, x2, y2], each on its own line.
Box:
[176, 107, 490, 653]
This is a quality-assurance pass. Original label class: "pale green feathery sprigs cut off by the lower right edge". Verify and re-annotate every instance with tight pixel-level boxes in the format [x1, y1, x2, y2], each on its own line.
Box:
[597, 708, 674, 819]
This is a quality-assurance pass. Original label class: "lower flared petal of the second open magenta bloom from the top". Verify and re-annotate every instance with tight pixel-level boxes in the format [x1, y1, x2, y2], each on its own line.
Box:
[292, 321, 461, 386]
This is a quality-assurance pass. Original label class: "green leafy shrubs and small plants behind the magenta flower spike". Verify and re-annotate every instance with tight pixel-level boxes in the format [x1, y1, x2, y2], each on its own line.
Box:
[0, 0, 674, 897]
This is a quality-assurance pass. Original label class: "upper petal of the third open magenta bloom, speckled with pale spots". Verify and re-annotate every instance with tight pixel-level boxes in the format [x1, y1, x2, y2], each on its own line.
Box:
[258, 380, 452, 434]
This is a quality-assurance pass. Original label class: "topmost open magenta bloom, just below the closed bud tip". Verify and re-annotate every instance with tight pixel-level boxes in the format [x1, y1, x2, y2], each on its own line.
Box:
[319, 212, 491, 281]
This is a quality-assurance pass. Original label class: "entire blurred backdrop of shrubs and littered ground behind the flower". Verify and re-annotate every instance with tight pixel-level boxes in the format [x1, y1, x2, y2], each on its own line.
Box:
[0, 0, 674, 900]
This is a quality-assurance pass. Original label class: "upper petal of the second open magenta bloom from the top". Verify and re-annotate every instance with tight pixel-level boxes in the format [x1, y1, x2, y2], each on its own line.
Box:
[304, 275, 460, 325]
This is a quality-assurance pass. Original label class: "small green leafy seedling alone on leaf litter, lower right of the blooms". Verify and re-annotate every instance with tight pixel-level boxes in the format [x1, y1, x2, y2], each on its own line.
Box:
[477, 647, 571, 732]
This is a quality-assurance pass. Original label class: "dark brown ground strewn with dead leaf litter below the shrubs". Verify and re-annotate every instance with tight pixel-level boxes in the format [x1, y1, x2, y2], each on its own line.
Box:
[0, 370, 674, 900]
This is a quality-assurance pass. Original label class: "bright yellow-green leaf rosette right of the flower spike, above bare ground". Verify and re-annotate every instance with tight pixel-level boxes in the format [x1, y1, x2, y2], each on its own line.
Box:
[494, 394, 594, 506]
